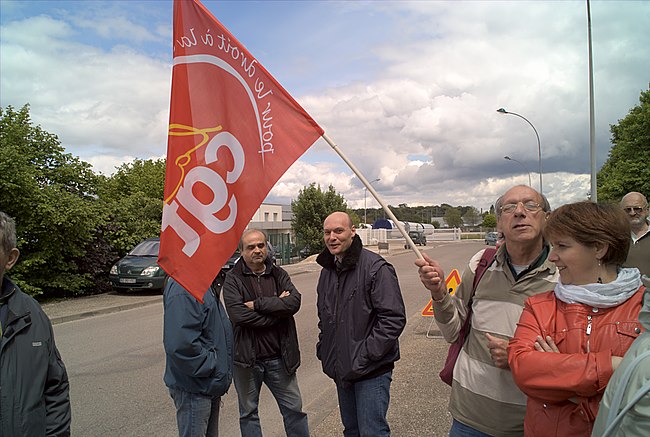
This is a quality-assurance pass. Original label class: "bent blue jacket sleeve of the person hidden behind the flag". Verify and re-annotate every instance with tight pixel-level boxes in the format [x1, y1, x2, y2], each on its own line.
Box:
[163, 283, 217, 378]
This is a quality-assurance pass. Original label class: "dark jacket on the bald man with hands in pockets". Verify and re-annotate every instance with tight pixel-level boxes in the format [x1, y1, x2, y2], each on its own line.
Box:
[316, 235, 406, 384]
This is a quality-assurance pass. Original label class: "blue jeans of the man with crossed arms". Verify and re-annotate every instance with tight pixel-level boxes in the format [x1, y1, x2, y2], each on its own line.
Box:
[233, 358, 309, 437]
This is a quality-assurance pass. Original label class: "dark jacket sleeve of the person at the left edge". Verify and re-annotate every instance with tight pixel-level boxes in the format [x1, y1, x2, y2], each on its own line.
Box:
[43, 316, 72, 437]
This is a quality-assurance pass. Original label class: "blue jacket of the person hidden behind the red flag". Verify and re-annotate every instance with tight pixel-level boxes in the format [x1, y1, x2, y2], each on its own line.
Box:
[163, 278, 232, 396]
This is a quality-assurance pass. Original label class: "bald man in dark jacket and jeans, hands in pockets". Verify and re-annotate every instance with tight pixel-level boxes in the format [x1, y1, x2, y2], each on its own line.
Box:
[316, 212, 406, 437]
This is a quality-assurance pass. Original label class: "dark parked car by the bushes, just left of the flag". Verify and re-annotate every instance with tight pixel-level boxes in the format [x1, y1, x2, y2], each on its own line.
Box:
[108, 238, 168, 291]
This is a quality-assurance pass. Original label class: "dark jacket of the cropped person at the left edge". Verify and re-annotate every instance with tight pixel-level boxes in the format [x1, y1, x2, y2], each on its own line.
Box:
[0, 277, 72, 437]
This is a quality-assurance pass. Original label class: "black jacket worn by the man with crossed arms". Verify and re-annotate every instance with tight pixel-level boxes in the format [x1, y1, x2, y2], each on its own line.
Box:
[223, 258, 301, 374]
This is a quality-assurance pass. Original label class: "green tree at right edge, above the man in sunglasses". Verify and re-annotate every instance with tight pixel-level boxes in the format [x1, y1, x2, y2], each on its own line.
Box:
[596, 89, 650, 201]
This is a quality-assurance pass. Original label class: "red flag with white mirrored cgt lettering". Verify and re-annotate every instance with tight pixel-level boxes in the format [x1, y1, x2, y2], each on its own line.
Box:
[158, 0, 323, 302]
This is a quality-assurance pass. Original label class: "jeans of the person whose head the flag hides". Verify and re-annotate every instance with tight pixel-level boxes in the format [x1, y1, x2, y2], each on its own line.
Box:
[169, 388, 221, 437]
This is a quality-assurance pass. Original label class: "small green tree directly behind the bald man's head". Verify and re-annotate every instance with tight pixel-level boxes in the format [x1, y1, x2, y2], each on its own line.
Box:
[291, 182, 347, 253]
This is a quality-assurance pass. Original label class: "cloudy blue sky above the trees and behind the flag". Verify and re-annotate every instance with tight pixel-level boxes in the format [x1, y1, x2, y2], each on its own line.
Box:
[0, 0, 650, 213]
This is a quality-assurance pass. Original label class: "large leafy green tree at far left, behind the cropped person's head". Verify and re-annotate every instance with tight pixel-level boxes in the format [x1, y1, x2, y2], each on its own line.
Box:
[0, 105, 105, 297]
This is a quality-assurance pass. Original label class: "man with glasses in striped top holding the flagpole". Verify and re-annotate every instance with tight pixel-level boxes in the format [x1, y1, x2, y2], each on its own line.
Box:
[415, 185, 557, 437]
